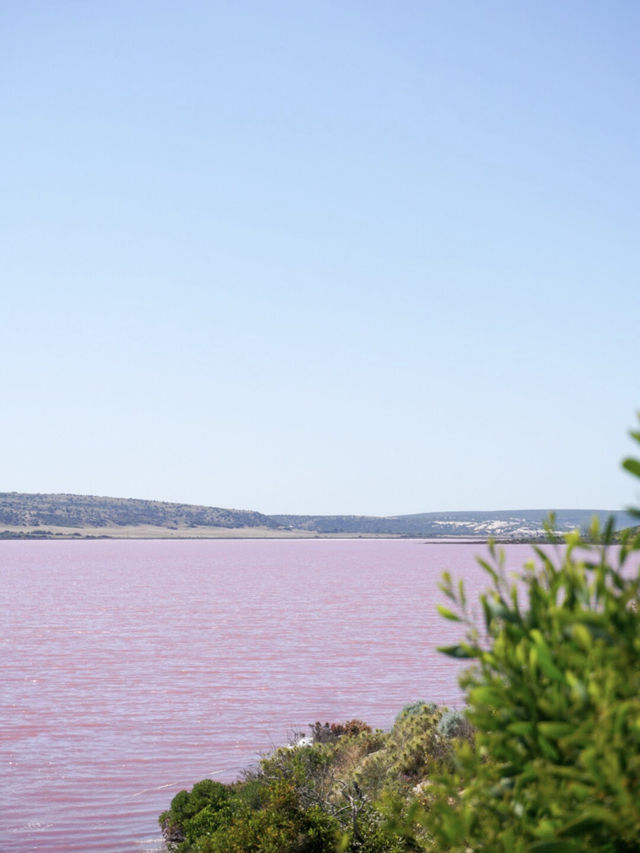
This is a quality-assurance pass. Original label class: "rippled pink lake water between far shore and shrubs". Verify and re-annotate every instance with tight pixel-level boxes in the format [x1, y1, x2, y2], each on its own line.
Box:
[0, 540, 530, 853]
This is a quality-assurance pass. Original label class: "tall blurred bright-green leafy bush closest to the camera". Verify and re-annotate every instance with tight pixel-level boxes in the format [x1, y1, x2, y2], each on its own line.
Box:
[410, 418, 640, 853]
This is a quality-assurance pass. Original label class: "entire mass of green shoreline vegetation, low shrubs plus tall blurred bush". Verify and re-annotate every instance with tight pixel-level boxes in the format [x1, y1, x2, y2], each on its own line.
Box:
[160, 414, 640, 853]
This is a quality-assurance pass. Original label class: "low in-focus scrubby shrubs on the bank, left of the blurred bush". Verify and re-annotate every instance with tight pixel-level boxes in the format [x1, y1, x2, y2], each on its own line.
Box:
[160, 703, 462, 853]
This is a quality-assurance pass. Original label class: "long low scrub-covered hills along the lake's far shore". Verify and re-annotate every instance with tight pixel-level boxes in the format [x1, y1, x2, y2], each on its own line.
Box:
[0, 492, 635, 540]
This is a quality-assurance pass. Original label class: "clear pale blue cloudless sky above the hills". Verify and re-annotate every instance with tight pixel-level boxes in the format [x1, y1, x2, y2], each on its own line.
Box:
[0, 0, 640, 515]
